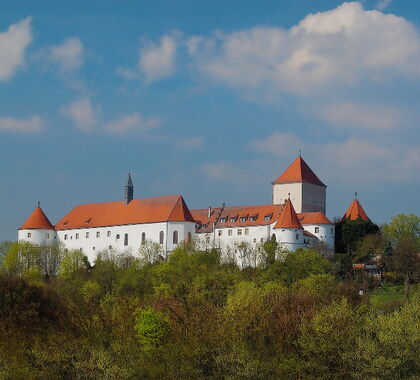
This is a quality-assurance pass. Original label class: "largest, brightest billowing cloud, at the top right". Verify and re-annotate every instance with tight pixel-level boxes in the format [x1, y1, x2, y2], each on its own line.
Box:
[188, 2, 420, 95]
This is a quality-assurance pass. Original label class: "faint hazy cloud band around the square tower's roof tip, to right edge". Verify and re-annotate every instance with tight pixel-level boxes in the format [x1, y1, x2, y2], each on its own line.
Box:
[251, 132, 420, 184]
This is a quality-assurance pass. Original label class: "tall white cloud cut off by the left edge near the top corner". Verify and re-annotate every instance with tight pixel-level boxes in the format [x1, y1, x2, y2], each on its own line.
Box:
[0, 17, 32, 81]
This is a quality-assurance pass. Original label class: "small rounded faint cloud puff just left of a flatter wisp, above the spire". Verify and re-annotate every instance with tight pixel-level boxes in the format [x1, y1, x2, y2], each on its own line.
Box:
[61, 98, 100, 132]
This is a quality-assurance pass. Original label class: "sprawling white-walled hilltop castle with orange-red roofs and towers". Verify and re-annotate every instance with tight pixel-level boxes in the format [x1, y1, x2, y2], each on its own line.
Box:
[18, 155, 368, 265]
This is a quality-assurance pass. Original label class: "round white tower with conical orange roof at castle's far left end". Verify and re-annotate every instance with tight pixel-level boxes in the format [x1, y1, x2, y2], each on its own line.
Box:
[18, 202, 56, 245]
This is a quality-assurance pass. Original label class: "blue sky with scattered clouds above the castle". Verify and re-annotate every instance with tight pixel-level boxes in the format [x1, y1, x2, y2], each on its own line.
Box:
[0, 0, 420, 241]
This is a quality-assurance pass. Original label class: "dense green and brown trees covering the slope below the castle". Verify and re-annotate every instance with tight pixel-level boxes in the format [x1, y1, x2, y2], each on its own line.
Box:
[0, 212, 420, 379]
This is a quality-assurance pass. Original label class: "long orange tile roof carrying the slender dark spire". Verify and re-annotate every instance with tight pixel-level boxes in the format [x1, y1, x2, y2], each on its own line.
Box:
[55, 195, 194, 230]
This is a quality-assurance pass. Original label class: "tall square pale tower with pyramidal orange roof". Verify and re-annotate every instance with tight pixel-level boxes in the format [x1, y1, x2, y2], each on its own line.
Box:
[272, 155, 327, 214]
